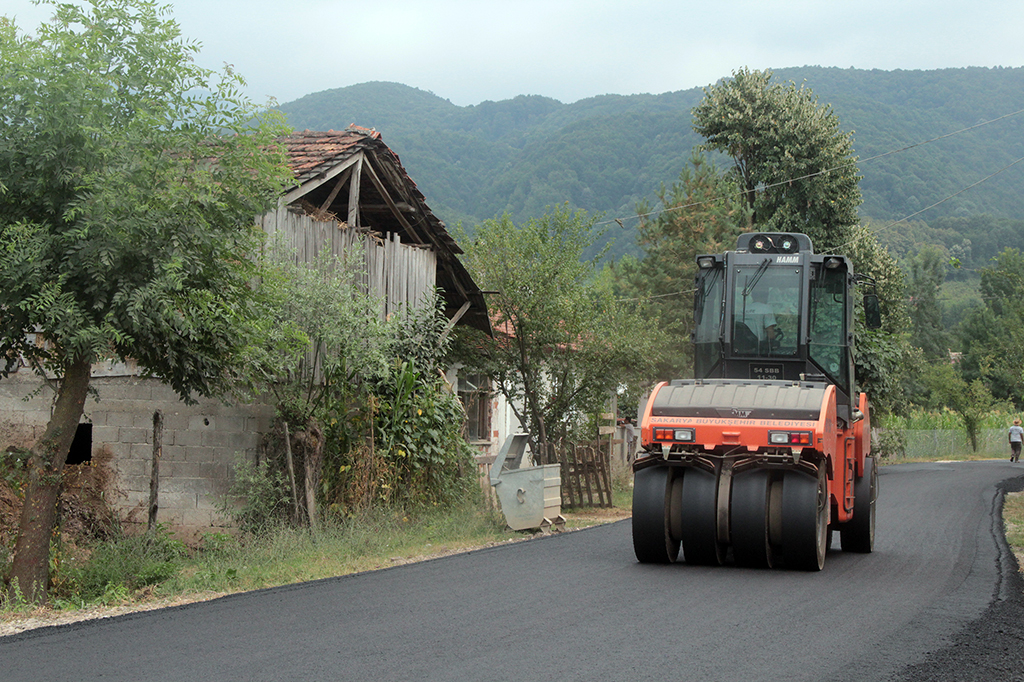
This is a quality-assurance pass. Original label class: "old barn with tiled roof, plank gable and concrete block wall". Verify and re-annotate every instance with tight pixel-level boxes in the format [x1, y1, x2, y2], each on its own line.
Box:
[0, 127, 489, 527]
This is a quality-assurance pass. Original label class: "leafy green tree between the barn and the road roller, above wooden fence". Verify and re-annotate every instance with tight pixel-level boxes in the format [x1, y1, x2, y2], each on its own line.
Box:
[459, 202, 654, 460]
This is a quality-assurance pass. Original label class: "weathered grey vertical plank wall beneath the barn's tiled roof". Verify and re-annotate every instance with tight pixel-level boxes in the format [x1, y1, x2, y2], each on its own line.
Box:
[261, 207, 437, 316]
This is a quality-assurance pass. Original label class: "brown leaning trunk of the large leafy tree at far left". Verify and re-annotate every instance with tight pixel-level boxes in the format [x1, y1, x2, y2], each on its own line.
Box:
[9, 357, 92, 603]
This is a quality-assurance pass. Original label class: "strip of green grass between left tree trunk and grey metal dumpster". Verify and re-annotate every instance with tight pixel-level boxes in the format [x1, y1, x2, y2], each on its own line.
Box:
[0, 503, 512, 615]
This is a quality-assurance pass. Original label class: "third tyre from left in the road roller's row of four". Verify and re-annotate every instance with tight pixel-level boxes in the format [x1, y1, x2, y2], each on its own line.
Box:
[729, 470, 772, 568]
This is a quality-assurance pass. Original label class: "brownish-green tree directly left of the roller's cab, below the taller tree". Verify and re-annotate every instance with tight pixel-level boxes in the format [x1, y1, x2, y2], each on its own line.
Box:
[627, 154, 751, 378]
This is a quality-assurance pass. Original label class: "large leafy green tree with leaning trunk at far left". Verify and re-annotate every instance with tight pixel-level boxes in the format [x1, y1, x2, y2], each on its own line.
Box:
[0, 0, 290, 601]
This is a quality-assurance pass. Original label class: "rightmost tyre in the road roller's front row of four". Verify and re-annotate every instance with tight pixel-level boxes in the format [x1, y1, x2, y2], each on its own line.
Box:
[782, 468, 828, 570]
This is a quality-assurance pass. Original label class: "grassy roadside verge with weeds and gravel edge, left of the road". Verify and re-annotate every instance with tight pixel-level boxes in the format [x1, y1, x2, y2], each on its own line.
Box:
[0, 446, 632, 636]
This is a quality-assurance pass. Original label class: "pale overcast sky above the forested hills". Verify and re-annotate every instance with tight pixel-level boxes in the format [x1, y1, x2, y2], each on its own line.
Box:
[0, 0, 1024, 105]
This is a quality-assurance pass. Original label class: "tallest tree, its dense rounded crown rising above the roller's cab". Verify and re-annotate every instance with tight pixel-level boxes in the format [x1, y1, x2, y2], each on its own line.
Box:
[693, 69, 861, 246]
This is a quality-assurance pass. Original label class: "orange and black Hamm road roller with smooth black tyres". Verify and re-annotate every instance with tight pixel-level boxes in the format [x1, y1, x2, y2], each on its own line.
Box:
[633, 232, 878, 570]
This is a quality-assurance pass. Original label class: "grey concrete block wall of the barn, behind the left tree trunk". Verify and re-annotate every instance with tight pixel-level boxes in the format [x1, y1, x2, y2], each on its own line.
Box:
[0, 373, 273, 528]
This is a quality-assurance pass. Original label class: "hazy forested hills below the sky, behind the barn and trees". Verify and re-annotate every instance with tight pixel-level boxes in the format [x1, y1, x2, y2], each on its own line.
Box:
[281, 67, 1024, 249]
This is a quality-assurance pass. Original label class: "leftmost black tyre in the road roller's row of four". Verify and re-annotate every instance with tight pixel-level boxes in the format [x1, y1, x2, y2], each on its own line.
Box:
[633, 467, 679, 563]
